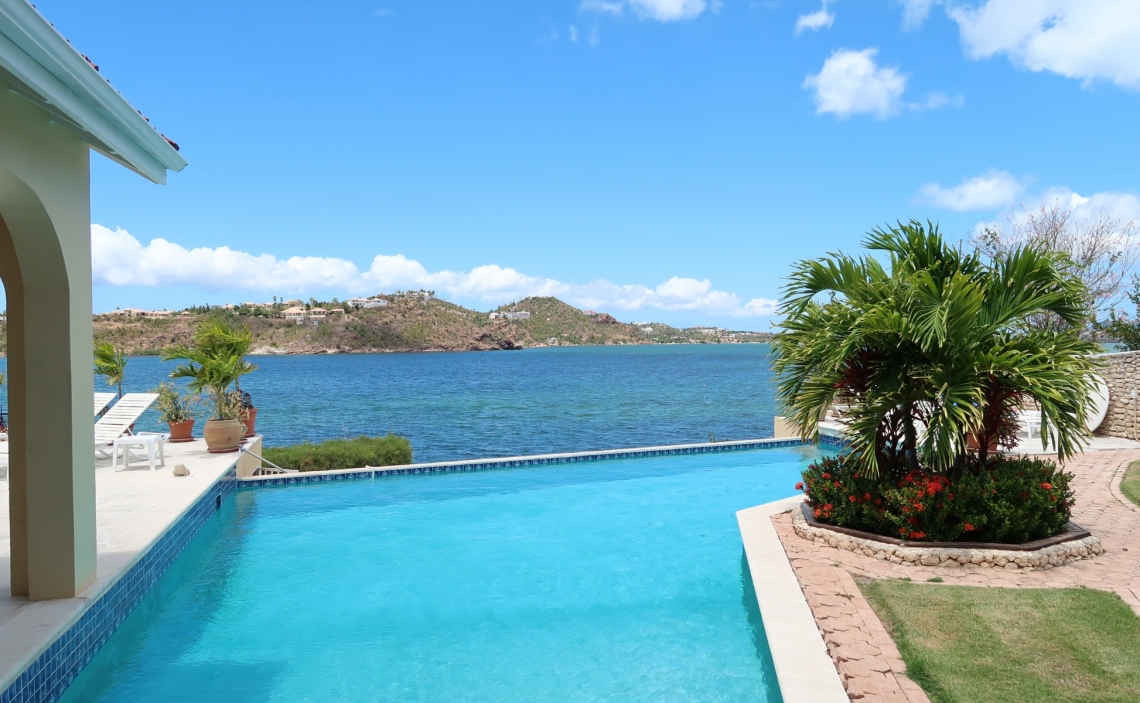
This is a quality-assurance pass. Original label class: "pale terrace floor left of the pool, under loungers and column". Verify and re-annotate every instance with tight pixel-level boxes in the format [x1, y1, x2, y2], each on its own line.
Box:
[0, 436, 261, 692]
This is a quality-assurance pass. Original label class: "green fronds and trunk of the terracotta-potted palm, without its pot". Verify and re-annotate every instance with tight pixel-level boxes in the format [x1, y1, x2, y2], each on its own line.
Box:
[162, 319, 258, 419]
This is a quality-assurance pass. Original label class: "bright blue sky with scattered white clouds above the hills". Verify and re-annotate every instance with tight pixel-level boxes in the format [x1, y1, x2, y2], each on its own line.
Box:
[24, 0, 1140, 329]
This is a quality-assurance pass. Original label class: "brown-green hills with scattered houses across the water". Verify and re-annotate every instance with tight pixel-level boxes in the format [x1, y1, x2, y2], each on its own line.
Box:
[78, 295, 772, 354]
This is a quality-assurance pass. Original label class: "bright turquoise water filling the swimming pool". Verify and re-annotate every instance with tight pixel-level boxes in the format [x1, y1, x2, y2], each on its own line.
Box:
[64, 448, 819, 703]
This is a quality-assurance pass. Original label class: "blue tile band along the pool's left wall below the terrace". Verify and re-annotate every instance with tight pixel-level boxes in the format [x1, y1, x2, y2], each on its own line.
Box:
[0, 466, 237, 703]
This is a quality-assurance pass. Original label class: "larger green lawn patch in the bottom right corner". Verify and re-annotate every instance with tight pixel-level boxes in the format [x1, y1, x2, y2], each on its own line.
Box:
[860, 580, 1140, 703]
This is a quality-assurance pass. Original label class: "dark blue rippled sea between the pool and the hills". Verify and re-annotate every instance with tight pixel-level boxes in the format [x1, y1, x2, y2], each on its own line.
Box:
[4, 344, 776, 461]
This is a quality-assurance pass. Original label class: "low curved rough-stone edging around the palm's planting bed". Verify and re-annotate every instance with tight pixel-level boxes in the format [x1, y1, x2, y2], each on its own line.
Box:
[791, 508, 1105, 570]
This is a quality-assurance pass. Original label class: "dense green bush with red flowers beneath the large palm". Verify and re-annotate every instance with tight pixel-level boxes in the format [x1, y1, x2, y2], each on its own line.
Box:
[796, 455, 1073, 543]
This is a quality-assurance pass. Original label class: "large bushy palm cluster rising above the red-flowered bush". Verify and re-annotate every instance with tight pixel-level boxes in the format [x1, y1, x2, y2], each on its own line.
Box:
[773, 221, 1097, 475]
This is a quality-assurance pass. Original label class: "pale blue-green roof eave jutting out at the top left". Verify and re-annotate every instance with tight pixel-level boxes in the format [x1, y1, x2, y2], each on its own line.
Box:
[0, 0, 186, 183]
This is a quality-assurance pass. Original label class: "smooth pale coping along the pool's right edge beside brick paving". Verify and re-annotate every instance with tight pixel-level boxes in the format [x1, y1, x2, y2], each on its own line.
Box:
[736, 496, 849, 703]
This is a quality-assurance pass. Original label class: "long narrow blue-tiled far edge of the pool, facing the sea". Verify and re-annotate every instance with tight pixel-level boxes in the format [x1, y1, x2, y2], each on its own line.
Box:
[238, 434, 847, 485]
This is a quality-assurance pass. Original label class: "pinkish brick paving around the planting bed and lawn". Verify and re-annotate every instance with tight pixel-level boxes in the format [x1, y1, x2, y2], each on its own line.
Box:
[772, 449, 1140, 703]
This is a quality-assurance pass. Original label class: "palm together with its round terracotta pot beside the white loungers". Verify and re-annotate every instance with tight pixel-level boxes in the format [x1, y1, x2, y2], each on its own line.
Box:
[162, 319, 258, 453]
